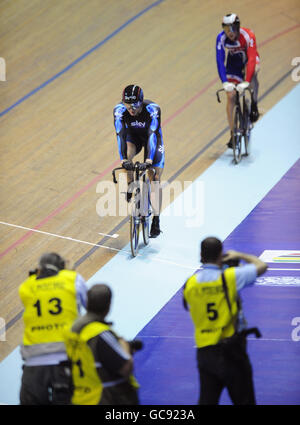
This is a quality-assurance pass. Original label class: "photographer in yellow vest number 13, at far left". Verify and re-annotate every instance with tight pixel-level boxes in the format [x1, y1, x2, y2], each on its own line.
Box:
[19, 253, 87, 405]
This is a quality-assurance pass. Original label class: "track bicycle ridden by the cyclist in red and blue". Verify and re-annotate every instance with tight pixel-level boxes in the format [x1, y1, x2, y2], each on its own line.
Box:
[216, 87, 253, 164]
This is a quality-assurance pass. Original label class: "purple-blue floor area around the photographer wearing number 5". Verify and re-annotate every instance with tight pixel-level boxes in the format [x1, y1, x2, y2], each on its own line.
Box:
[136, 160, 300, 405]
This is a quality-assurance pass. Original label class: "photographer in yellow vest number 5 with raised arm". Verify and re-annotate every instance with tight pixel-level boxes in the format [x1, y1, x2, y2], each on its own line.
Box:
[183, 237, 267, 405]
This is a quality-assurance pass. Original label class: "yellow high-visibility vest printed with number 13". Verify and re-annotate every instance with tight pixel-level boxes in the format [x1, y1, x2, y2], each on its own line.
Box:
[19, 270, 78, 346]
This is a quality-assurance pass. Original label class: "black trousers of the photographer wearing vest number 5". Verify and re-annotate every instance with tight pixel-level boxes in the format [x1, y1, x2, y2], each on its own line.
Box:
[197, 336, 256, 405]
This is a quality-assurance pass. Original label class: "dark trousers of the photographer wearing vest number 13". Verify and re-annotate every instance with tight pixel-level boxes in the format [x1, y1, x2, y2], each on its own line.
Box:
[20, 364, 72, 405]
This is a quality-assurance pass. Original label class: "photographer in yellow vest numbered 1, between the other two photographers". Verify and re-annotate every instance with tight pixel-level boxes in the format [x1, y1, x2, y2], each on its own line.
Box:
[65, 284, 142, 405]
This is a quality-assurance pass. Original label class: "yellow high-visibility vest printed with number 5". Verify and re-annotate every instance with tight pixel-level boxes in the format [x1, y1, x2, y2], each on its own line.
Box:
[183, 267, 238, 348]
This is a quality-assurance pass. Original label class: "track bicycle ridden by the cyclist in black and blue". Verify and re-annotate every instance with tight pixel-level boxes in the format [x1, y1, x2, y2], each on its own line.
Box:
[112, 161, 155, 257]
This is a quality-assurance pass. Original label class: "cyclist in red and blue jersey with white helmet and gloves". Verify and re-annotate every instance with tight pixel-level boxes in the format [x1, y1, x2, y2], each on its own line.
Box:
[216, 13, 260, 148]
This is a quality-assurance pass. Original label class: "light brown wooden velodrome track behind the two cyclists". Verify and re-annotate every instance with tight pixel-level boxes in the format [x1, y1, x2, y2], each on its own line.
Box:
[0, 0, 300, 360]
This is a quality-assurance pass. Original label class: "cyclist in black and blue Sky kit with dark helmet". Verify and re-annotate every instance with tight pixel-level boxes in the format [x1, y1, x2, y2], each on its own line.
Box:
[114, 84, 165, 238]
